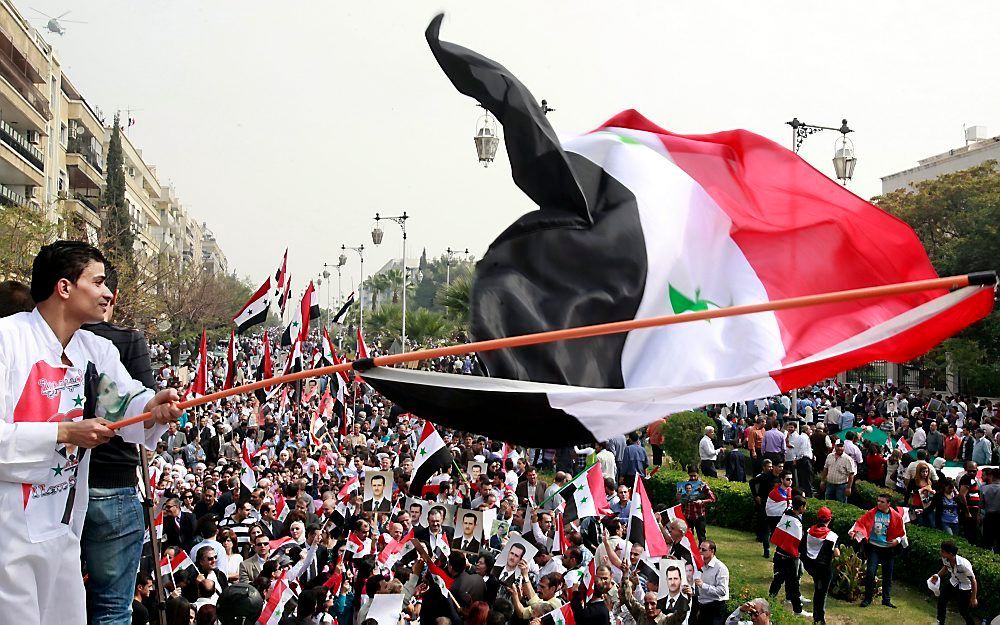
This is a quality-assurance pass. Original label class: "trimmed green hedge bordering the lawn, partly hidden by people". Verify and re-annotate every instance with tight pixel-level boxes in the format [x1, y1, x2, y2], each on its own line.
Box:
[647, 471, 1000, 619]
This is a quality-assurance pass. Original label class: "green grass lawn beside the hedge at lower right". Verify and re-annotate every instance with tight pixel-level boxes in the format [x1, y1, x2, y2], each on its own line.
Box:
[708, 520, 962, 625]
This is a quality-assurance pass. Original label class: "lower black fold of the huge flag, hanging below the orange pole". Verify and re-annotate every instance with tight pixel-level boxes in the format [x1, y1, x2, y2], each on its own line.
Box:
[364, 367, 595, 447]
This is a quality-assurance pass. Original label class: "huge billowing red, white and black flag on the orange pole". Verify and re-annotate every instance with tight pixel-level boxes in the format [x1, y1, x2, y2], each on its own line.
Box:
[356, 16, 993, 447]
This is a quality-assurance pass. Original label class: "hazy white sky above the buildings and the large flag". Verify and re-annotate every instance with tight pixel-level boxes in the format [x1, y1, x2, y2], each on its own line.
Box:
[23, 0, 1000, 298]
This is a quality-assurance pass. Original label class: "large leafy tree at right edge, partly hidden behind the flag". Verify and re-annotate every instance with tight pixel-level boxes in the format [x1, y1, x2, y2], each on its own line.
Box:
[872, 161, 1000, 395]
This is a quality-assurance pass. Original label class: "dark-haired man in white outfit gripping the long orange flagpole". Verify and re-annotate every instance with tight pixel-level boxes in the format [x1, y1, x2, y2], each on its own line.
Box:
[0, 241, 180, 625]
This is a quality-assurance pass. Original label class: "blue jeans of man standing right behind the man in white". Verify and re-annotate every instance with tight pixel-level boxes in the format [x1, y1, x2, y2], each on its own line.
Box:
[80, 488, 145, 625]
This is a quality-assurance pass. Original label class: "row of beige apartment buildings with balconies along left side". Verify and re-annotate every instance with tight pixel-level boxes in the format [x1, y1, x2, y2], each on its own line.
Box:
[0, 0, 227, 272]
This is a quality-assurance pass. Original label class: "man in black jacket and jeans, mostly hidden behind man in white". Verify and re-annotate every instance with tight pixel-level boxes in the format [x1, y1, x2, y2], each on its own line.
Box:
[80, 265, 156, 625]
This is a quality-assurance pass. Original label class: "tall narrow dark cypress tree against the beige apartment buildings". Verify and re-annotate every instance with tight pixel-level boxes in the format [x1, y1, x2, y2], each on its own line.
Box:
[100, 113, 135, 269]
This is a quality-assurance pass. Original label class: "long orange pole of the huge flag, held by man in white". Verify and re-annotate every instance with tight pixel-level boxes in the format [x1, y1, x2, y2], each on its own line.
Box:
[108, 271, 997, 430]
